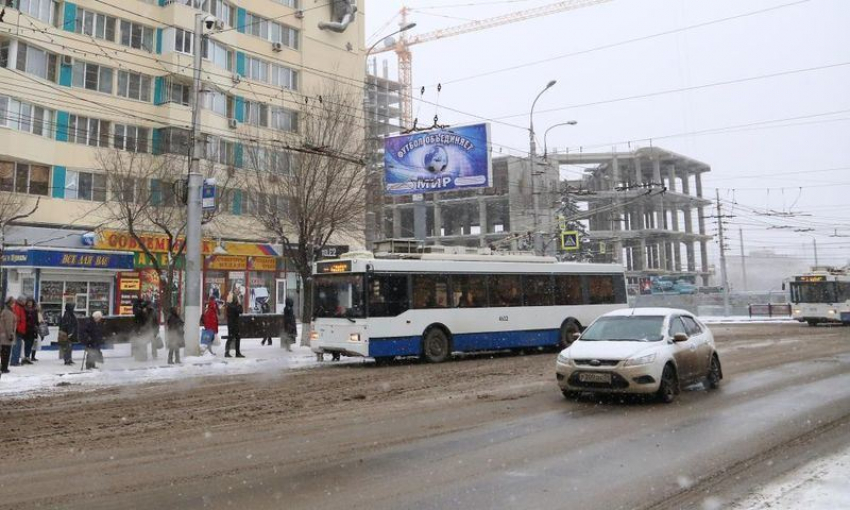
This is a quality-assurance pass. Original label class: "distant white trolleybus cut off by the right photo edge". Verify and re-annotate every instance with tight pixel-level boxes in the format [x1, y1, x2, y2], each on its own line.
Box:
[789, 268, 850, 326]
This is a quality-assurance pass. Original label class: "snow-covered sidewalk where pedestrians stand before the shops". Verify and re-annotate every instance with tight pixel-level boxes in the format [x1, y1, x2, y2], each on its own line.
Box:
[0, 330, 362, 399]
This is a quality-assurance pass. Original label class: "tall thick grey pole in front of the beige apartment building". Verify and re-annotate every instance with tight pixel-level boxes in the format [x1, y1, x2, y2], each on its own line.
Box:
[183, 12, 207, 356]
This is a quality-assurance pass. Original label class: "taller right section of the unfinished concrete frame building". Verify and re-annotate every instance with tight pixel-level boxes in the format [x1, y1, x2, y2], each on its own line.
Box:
[549, 147, 712, 285]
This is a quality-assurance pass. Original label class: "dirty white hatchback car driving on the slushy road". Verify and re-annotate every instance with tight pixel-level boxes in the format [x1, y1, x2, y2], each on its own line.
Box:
[556, 308, 723, 403]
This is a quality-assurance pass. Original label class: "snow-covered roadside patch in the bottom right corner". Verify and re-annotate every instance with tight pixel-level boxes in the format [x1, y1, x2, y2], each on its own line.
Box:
[732, 448, 850, 510]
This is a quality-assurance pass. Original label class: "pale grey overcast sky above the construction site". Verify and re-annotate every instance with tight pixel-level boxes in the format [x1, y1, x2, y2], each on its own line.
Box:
[361, 0, 850, 264]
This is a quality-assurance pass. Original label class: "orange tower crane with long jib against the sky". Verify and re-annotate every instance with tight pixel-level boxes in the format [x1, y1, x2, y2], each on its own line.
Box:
[372, 0, 612, 128]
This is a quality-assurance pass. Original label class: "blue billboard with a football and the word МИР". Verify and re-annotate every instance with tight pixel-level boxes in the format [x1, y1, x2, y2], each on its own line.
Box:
[384, 124, 493, 195]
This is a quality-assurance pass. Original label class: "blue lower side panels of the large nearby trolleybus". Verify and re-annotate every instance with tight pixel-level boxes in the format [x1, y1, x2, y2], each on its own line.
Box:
[369, 329, 561, 357]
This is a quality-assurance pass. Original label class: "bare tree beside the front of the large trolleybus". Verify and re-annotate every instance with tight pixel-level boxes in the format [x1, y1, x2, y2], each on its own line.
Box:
[245, 90, 366, 345]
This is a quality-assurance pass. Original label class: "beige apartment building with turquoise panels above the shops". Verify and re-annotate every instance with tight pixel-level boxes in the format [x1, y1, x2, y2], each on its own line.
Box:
[0, 0, 365, 313]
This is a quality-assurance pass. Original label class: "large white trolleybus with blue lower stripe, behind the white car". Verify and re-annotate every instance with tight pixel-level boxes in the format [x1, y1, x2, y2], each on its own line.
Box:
[311, 253, 627, 362]
